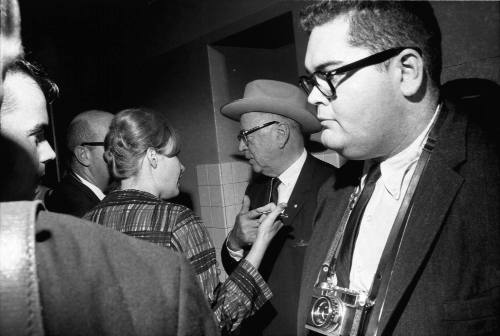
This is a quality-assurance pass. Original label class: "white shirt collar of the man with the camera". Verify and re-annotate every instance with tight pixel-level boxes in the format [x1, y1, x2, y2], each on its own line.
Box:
[365, 105, 441, 200]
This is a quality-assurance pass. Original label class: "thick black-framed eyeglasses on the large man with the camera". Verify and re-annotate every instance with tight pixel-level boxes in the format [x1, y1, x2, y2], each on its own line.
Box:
[299, 47, 421, 99]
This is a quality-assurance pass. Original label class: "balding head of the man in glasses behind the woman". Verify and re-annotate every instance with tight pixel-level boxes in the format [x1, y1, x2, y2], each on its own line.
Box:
[67, 110, 113, 190]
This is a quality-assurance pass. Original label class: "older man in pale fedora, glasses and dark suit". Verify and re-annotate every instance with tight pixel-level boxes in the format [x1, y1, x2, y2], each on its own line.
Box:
[221, 79, 335, 335]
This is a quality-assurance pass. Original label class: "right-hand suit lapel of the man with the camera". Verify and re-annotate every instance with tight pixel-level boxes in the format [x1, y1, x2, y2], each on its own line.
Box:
[379, 103, 466, 334]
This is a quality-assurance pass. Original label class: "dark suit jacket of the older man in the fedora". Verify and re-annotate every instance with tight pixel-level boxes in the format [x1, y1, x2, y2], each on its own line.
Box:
[222, 154, 335, 336]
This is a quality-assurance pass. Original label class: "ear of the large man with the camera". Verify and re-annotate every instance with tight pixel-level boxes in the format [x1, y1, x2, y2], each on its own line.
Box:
[397, 49, 425, 97]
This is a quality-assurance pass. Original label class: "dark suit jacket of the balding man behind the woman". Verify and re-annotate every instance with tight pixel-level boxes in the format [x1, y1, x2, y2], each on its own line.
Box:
[44, 173, 100, 217]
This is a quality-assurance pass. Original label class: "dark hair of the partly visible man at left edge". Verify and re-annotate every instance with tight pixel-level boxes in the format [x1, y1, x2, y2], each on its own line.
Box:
[6, 59, 59, 104]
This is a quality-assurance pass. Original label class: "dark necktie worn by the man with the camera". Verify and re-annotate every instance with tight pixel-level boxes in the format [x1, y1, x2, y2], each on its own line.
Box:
[335, 163, 380, 288]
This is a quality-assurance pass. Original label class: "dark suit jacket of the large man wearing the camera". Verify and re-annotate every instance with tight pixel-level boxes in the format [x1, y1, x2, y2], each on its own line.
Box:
[297, 100, 500, 335]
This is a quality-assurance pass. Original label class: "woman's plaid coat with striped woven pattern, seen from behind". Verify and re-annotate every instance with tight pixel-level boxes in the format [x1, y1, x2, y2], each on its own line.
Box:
[84, 190, 272, 330]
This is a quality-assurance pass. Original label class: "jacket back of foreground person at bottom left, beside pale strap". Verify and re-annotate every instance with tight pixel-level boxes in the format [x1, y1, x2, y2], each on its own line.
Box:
[36, 211, 218, 336]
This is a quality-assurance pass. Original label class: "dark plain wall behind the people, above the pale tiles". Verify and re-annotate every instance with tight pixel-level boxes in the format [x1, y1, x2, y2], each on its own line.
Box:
[16, 0, 500, 210]
